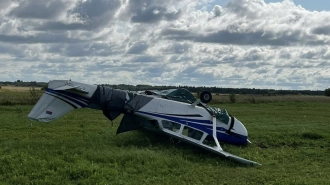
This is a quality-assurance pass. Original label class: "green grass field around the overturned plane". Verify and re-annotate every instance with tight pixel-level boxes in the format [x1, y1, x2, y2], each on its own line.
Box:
[0, 89, 330, 184]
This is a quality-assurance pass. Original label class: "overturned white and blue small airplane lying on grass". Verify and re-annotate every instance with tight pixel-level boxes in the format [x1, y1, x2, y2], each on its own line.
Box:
[28, 80, 260, 165]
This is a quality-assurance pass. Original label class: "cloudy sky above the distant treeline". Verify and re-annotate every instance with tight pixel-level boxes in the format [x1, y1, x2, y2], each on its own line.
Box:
[0, 0, 330, 90]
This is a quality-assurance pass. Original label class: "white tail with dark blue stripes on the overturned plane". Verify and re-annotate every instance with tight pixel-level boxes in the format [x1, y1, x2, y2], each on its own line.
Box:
[28, 80, 97, 122]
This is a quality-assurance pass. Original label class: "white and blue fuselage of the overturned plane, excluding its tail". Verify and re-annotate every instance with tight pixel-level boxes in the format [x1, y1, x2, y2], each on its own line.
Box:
[131, 97, 248, 145]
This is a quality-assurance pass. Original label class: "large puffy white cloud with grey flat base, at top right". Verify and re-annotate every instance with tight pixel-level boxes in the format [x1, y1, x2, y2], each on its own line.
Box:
[161, 0, 329, 46]
